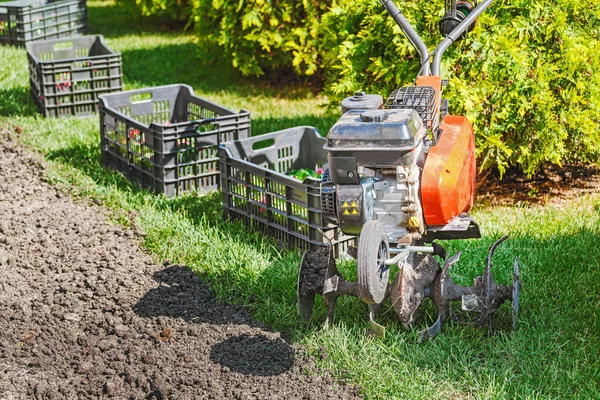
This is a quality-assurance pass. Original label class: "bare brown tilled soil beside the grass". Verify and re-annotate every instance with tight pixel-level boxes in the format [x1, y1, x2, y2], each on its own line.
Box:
[0, 133, 358, 399]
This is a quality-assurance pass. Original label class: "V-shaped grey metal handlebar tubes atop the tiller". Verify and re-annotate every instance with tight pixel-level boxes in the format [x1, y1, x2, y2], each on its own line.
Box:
[379, 0, 494, 76]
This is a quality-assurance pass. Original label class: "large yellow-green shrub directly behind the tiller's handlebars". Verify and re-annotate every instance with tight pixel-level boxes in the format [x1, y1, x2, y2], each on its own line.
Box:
[320, 0, 600, 174]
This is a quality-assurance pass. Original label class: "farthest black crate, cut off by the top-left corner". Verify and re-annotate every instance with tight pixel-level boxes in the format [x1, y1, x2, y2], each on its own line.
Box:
[0, 0, 88, 46]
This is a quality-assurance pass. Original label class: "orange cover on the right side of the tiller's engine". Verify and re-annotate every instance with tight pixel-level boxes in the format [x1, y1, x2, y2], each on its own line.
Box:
[421, 115, 476, 226]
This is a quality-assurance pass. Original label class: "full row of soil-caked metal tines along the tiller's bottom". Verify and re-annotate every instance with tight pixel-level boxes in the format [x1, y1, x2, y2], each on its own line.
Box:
[298, 236, 521, 342]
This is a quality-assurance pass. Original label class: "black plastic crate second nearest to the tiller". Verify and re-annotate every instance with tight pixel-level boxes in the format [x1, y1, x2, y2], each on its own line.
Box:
[99, 85, 250, 196]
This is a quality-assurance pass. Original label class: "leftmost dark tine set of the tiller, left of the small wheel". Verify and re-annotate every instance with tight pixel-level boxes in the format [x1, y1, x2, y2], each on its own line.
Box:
[297, 247, 358, 323]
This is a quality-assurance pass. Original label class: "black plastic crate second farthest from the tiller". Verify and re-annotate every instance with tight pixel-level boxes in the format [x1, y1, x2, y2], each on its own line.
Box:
[27, 35, 123, 117]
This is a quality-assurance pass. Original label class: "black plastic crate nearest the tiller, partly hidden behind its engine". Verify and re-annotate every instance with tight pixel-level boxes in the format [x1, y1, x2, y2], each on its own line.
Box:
[220, 127, 354, 257]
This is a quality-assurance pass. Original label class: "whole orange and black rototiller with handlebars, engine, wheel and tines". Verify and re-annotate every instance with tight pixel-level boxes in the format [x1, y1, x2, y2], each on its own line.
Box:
[298, 0, 520, 340]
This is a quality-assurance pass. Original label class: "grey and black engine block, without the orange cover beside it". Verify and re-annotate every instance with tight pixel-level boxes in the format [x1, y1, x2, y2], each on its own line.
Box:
[324, 109, 428, 241]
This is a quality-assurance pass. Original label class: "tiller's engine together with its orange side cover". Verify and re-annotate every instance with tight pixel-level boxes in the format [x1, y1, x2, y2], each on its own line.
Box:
[321, 86, 478, 244]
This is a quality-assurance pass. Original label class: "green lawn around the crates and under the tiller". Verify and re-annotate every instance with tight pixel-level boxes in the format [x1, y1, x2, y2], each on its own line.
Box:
[0, 1, 600, 399]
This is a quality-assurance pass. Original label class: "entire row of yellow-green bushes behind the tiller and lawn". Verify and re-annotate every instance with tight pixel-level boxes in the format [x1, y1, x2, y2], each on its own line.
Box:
[121, 0, 600, 175]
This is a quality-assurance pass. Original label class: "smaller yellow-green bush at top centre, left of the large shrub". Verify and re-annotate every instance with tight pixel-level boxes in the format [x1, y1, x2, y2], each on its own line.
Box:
[192, 0, 329, 76]
